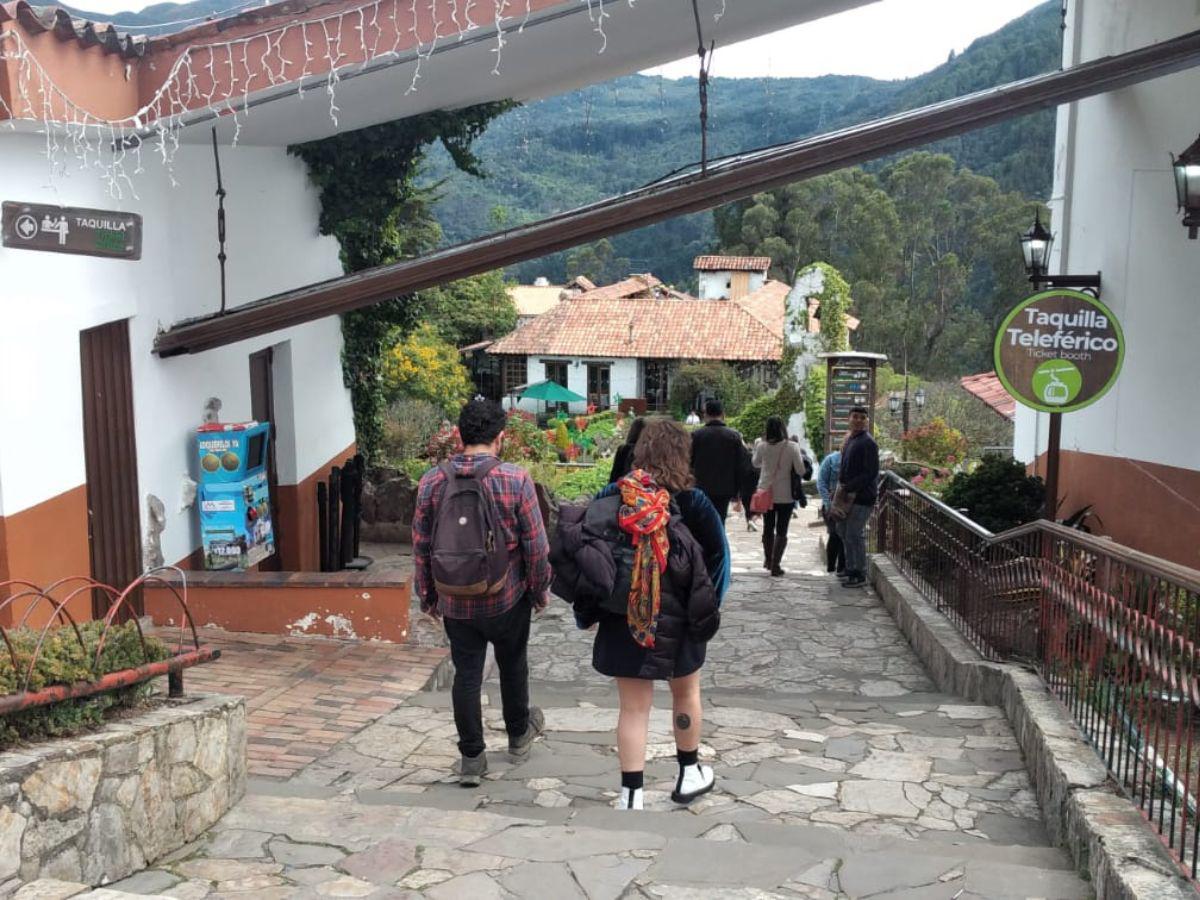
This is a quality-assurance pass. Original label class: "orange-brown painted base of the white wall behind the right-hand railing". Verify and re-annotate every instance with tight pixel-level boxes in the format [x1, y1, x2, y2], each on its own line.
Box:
[1033, 450, 1200, 569]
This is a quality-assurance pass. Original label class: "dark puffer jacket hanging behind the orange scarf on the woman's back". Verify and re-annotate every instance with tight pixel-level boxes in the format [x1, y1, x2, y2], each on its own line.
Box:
[550, 497, 721, 678]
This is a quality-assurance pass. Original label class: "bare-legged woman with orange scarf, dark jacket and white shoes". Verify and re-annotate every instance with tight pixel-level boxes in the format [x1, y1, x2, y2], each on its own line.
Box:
[551, 418, 728, 810]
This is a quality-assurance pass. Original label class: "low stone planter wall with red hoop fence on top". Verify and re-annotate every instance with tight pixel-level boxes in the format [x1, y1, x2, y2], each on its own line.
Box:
[0, 695, 246, 896]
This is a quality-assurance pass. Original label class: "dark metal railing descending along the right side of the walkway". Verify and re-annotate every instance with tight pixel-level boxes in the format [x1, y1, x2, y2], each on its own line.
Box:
[872, 473, 1200, 880]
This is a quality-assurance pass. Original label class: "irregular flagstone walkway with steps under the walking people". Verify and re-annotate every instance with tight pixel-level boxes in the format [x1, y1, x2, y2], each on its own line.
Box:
[100, 508, 1091, 900]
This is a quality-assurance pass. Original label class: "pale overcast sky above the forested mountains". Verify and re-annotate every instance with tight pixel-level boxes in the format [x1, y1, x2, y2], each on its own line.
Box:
[652, 0, 1044, 79]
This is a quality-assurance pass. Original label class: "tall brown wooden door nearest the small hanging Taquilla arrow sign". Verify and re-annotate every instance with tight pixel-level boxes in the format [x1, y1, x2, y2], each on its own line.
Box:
[79, 319, 142, 618]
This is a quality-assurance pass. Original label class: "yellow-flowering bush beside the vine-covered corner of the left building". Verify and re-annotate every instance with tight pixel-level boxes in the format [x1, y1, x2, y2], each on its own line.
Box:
[383, 323, 472, 419]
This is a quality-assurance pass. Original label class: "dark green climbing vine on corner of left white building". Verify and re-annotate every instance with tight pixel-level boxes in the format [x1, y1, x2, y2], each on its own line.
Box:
[288, 101, 515, 458]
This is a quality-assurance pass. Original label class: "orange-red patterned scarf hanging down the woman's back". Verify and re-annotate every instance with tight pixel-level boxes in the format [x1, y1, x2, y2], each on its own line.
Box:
[617, 469, 671, 647]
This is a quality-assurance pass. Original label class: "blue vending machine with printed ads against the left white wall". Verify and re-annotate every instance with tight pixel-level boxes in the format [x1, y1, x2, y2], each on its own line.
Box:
[196, 422, 275, 569]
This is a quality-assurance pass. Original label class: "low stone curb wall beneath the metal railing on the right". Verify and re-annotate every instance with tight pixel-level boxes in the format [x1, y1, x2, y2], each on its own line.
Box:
[871, 554, 1198, 900]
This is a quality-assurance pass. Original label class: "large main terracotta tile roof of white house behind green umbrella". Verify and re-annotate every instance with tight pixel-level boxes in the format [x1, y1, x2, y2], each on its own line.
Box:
[487, 299, 784, 361]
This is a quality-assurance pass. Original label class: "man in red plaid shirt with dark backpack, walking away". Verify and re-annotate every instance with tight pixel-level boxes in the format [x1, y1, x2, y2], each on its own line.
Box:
[413, 400, 551, 787]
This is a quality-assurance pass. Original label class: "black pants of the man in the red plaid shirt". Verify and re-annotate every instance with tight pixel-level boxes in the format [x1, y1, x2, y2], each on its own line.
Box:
[444, 599, 533, 756]
